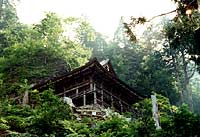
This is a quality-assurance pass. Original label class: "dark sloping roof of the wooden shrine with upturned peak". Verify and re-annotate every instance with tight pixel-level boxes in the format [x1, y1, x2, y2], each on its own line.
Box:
[32, 58, 144, 99]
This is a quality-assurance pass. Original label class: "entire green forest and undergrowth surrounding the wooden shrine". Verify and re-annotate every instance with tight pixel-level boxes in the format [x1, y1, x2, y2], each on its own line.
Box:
[0, 0, 200, 137]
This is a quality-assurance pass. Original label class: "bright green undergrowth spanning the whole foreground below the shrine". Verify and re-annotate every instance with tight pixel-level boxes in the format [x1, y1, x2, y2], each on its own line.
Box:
[0, 90, 200, 137]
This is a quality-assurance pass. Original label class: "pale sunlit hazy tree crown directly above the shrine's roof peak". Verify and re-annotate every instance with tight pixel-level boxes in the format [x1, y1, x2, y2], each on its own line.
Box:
[65, 17, 108, 60]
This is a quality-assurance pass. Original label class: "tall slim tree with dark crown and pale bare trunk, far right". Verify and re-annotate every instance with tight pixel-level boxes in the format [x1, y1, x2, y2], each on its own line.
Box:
[164, 10, 200, 110]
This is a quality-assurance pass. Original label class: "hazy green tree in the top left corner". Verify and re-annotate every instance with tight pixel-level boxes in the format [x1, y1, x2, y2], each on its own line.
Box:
[0, 0, 23, 56]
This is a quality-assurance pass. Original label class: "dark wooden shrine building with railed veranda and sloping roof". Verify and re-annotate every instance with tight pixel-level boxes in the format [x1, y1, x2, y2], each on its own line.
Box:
[33, 58, 143, 112]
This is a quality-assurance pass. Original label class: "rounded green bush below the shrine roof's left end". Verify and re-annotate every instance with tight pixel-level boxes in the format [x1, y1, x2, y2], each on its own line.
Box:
[28, 90, 71, 136]
